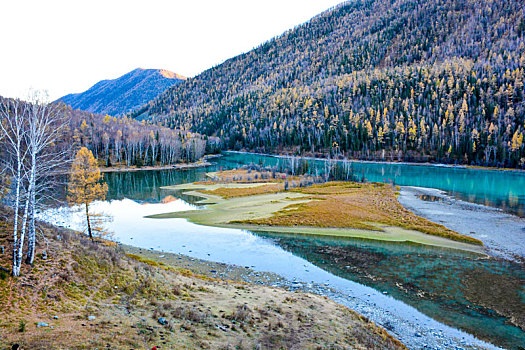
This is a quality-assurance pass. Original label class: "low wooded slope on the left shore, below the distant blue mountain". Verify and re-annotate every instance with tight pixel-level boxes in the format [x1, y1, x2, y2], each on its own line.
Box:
[0, 96, 209, 168]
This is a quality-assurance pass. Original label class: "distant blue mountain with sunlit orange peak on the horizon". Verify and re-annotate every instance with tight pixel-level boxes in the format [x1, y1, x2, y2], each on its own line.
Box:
[57, 68, 186, 116]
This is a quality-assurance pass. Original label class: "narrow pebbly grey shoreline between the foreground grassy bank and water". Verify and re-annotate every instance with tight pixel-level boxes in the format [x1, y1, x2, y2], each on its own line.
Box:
[121, 244, 499, 349]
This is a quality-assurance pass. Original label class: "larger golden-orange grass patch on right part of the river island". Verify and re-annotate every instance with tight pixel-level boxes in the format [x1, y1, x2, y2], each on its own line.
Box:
[235, 182, 482, 245]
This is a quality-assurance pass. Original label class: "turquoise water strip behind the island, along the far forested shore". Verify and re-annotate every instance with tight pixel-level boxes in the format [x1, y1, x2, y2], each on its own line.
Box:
[105, 152, 525, 217]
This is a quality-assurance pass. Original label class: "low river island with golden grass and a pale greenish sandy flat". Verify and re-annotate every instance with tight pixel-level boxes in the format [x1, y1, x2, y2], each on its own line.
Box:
[159, 170, 482, 246]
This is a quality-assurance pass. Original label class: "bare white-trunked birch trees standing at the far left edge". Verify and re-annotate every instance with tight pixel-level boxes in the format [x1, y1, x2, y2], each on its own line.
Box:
[0, 92, 67, 276]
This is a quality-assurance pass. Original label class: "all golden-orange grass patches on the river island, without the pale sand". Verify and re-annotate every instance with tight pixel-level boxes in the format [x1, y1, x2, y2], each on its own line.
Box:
[193, 169, 483, 245]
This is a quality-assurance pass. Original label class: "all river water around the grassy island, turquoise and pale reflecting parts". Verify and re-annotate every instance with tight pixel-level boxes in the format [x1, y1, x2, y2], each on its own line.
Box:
[95, 153, 525, 349]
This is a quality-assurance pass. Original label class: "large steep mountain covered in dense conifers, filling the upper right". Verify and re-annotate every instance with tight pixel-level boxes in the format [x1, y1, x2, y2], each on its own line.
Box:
[132, 0, 525, 167]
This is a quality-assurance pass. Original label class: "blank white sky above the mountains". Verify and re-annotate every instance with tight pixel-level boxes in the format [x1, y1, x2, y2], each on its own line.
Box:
[0, 0, 342, 100]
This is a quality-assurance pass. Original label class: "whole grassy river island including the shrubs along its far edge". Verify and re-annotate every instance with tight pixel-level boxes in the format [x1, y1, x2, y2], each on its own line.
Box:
[160, 169, 482, 245]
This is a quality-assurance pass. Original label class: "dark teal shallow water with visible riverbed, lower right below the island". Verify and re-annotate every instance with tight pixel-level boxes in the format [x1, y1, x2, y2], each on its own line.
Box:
[257, 233, 525, 348]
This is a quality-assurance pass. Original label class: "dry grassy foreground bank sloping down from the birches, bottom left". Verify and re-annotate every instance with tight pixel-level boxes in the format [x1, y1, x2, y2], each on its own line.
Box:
[0, 213, 403, 349]
